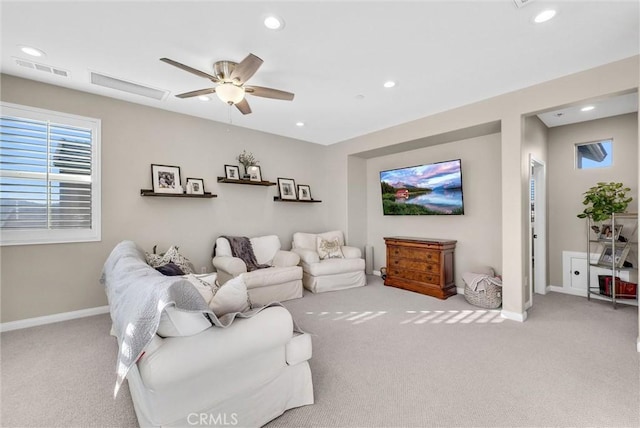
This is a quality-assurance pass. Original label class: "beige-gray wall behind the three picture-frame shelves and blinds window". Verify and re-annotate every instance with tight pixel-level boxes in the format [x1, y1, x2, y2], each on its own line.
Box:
[0, 75, 331, 322]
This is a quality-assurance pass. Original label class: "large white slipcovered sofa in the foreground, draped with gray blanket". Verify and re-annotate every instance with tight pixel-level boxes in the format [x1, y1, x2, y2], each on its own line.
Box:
[103, 241, 314, 427]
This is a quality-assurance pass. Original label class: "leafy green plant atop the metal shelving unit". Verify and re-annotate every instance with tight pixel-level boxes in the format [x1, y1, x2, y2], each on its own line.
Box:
[578, 182, 633, 222]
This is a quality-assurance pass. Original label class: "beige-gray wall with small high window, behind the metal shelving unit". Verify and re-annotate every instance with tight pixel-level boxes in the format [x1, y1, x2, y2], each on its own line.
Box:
[548, 113, 638, 286]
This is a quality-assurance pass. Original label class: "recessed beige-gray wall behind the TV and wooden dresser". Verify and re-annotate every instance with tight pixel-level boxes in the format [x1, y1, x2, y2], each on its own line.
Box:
[367, 134, 502, 280]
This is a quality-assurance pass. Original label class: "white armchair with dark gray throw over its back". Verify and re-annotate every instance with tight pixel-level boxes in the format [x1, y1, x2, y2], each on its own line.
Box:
[213, 235, 302, 306]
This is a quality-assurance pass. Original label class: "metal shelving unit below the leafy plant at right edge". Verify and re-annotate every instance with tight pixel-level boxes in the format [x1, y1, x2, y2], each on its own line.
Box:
[587, 213, 638, 309]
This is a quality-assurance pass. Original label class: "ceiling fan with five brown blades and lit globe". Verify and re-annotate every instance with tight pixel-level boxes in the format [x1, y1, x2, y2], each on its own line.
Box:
[160, 54, 294, 114]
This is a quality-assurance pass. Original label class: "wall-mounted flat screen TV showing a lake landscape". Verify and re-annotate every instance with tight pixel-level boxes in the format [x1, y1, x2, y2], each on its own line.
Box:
[380, 159, 464, 215]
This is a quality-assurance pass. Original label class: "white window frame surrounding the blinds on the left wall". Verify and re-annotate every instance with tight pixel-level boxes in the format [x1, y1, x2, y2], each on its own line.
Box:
[0, 101, 102, 247]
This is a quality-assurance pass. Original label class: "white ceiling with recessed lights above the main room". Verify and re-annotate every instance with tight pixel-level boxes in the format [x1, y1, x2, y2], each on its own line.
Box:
[0, 0, 640, 144]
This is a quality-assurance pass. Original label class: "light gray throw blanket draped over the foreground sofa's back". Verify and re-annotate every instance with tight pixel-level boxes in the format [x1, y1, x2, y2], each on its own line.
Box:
[100, 241, 288, 397]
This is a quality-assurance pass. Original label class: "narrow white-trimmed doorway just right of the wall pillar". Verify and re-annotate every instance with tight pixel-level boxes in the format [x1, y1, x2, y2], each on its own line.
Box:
[525, 156, 547, 308]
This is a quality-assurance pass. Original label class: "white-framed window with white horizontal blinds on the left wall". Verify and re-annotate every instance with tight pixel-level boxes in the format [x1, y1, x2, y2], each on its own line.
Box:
[0, 103, 100, 245]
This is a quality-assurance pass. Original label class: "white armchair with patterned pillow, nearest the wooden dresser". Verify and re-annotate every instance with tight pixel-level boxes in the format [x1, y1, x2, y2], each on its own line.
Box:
[291, 230, 367, 293]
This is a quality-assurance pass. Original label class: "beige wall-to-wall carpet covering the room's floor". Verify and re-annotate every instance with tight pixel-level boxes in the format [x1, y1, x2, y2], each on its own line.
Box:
[0, 277, 640, 428]
